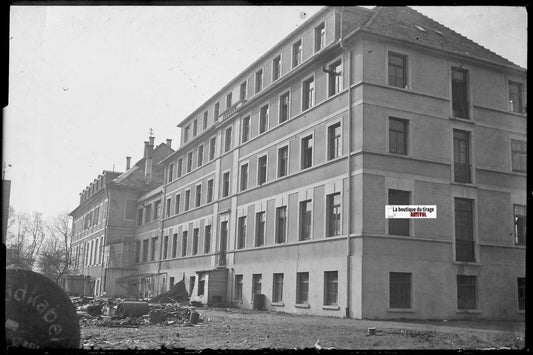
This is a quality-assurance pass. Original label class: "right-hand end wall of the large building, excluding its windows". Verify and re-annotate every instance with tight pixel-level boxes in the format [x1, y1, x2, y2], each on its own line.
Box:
[361, 40, 526, 320]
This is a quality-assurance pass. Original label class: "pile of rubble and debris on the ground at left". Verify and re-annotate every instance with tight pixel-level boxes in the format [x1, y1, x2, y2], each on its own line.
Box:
[71, 296, 203, 328]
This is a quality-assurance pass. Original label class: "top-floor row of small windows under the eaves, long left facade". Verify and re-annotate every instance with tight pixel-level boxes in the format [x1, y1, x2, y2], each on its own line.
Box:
[183, 22, 340, 143]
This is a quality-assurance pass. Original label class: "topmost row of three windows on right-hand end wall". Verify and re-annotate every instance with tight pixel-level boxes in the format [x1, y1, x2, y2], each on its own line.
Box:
[388, 52, 526, 115]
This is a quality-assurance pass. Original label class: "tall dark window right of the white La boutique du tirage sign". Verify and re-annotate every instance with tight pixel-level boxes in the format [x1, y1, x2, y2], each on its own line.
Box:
[455, 198, 475, 261]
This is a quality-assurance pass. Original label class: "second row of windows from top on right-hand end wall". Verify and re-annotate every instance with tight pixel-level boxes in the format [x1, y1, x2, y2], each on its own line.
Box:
[389, 117, 527, 177]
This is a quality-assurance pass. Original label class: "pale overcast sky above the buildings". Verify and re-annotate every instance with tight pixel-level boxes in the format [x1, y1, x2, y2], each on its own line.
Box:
[3, 6, 527, 220]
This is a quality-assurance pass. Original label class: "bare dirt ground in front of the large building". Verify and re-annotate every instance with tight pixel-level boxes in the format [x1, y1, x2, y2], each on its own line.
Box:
[81, 308, 524, 349]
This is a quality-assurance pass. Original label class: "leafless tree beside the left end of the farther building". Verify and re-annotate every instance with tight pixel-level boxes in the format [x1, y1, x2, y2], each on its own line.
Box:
[38, 213, 73, 283]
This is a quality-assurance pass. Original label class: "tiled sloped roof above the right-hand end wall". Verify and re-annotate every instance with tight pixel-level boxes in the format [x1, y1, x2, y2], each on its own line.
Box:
[362, 6, 520, 69]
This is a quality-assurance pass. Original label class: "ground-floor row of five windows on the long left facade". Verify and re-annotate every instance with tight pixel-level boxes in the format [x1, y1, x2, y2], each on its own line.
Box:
[233, 271, 339, 306]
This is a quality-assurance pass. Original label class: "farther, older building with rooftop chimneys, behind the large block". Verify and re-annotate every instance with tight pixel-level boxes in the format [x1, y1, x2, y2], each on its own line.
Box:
[69, 137, 173, 296]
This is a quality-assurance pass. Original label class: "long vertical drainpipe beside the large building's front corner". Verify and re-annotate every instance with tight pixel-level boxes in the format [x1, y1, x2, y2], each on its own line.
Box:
[339, 6, 353, 318]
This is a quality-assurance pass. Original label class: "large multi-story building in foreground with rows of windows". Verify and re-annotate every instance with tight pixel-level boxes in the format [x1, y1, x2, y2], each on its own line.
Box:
[70, 7, 527, 319]
